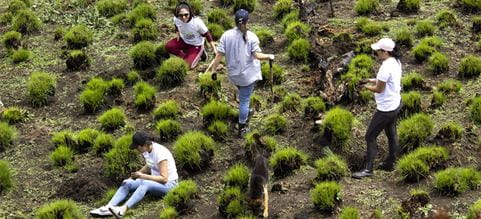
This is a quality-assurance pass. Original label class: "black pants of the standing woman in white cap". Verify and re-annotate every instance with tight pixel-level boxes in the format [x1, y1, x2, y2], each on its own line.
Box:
[365, 106, 401, 170]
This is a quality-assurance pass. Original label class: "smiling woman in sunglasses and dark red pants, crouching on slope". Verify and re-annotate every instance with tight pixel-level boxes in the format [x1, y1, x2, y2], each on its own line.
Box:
[165, 2, 217, 69]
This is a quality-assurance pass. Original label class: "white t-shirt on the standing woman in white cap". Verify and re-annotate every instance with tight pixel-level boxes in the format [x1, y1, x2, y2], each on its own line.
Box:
[374, 57, 402, 112]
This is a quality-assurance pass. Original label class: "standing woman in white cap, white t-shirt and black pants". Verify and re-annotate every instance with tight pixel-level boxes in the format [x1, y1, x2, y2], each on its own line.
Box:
[352, 38, 402, 179]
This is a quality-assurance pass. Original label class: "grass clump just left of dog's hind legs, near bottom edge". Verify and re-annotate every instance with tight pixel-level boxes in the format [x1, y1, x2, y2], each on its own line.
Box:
[217, 187, 244, 218]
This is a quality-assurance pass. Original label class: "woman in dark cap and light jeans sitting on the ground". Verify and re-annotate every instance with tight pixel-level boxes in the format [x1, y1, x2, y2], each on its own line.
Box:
[90, 132, 179, 218]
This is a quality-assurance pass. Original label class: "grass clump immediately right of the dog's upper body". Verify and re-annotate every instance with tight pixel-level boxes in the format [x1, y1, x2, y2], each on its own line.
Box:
[269, 147, 307, 177]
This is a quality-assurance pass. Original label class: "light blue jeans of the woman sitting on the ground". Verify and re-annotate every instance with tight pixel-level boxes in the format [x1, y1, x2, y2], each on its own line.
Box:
[109, 178, 177, 208]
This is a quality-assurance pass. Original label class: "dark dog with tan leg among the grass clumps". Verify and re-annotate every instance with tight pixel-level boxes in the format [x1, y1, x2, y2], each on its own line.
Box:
[248, 134, 269, 218]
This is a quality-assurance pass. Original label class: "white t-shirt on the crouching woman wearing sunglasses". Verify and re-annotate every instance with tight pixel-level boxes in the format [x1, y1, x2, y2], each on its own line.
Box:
[174, 17, 209, 46]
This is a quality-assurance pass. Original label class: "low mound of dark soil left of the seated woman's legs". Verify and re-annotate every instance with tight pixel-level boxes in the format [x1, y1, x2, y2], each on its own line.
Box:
[57, 162, 113, 202]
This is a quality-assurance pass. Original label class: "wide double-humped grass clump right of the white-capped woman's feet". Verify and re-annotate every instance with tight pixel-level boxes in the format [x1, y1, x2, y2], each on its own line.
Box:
[396, 146, 449, 182]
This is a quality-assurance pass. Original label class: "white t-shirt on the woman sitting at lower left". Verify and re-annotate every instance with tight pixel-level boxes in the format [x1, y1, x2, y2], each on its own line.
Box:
[142, 142, 179, 181]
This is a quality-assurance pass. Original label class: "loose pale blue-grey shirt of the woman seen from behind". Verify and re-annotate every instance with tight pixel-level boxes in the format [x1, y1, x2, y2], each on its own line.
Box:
[217, 27, 262, 86]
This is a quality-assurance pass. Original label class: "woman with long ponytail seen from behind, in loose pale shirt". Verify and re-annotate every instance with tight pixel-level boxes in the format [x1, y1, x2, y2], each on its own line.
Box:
[212, 9, 274, 135]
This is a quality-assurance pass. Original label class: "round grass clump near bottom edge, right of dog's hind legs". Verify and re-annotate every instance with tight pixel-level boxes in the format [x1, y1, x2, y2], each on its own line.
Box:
[311, 182, 341, 212]
